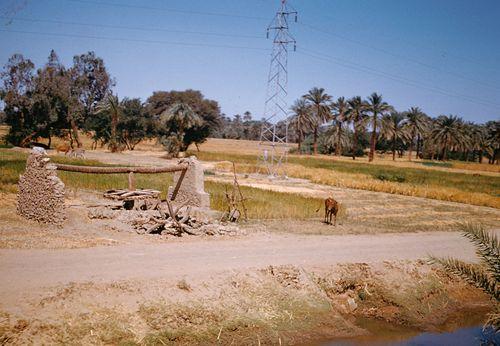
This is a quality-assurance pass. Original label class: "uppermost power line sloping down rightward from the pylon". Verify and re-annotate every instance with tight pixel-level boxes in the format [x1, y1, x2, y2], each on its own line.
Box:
[299, 22, 500, 90]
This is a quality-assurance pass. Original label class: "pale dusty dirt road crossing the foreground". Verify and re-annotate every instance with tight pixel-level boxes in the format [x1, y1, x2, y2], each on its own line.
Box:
[0, 232, 475, 303]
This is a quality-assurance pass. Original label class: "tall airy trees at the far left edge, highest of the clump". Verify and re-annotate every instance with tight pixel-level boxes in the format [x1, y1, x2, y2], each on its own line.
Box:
[0, 50, 112, 147]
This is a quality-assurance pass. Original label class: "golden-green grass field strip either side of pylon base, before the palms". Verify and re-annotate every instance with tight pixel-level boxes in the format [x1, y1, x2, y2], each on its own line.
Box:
[192, 151, 500, 208]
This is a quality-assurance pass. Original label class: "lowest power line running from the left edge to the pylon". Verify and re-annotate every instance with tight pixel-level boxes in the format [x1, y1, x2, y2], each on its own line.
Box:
[0, 29, 269, 51]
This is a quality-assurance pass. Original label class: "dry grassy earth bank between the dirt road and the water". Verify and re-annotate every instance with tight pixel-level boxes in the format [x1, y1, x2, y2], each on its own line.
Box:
[0, 262, 492, 345]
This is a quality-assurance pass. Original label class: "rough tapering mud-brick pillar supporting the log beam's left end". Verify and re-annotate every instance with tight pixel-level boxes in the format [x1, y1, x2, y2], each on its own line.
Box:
[17, 148, 66, 225]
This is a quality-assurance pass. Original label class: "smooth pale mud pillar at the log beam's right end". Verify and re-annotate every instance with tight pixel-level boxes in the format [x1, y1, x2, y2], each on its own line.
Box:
[168, 156, 210, 208]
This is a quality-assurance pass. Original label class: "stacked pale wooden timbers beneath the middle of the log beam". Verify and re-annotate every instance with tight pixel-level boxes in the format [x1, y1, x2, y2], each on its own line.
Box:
[104, 189, 161, 210]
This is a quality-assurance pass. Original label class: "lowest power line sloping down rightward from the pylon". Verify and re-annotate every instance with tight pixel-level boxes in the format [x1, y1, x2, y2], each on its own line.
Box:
[297, 50, 500, 109]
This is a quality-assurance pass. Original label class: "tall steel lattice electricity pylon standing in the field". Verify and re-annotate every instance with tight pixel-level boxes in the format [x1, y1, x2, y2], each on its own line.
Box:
[260, 0, 297, 176]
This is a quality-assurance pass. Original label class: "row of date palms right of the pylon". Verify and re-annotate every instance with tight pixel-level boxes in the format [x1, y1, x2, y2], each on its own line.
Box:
[289, 88, 500, 164]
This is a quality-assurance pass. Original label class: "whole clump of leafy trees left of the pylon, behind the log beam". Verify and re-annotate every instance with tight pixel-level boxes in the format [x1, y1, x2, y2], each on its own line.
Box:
[0, 51, 222, 155]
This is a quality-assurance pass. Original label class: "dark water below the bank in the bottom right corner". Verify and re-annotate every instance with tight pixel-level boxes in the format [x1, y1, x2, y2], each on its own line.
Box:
[323, 326, 500, 346]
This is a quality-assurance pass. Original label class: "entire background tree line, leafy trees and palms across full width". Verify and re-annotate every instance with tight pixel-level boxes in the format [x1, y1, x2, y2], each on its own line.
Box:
[0, 51, 500, 164]
